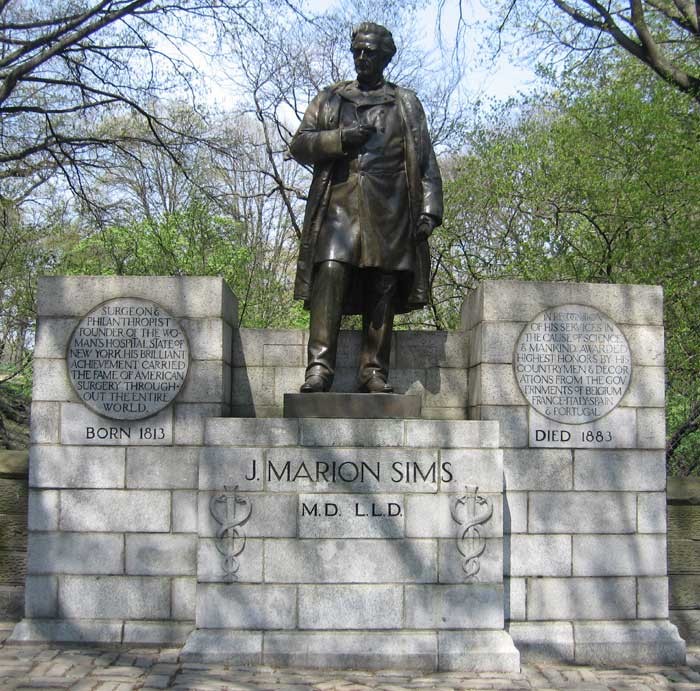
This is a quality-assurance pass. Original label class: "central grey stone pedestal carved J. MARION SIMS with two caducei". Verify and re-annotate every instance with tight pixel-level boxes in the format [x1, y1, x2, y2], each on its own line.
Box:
[183, 414, 519, 671]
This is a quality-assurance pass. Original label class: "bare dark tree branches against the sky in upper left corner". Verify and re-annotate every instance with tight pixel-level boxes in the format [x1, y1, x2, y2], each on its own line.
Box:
[0, 0, 298, 204]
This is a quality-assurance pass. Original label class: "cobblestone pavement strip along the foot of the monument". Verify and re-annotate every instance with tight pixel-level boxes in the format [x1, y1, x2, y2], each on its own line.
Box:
[0, 628, 700, 691]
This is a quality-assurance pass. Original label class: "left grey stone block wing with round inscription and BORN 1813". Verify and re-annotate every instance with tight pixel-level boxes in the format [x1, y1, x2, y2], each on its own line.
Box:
[15, 276, 237, 643]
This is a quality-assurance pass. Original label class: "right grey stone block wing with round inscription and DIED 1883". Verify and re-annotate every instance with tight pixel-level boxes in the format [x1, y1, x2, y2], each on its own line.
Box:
[463, 281, 677, 662]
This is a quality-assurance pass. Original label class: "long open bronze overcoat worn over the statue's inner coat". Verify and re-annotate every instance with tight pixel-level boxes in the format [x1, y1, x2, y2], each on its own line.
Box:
[289, 82, 442, 314]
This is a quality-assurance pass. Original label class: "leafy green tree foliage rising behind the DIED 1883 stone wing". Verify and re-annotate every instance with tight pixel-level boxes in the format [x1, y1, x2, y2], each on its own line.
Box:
[442, 63, 700, 473]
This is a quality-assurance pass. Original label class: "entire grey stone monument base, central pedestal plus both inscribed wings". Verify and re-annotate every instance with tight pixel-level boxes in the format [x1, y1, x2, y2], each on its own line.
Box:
[12, 277, 685, 671]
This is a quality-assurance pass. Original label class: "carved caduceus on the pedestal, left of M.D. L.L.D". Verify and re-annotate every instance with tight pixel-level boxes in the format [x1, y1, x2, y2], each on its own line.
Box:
[209, 485, 253, 581]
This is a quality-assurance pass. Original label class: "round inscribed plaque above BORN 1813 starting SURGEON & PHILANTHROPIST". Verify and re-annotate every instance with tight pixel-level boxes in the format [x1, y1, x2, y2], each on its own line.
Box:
[67, 298, 190, 420]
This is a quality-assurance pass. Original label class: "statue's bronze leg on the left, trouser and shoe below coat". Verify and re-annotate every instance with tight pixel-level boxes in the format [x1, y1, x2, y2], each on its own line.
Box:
[301, 261, 351, 393]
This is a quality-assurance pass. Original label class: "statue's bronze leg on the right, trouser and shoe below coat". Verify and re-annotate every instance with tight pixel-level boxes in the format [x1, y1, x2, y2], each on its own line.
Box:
[358, 270, 398, 393]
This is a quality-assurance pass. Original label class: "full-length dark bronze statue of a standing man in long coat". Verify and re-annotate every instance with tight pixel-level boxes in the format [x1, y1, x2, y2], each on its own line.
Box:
[289, 22, 442, 393]
